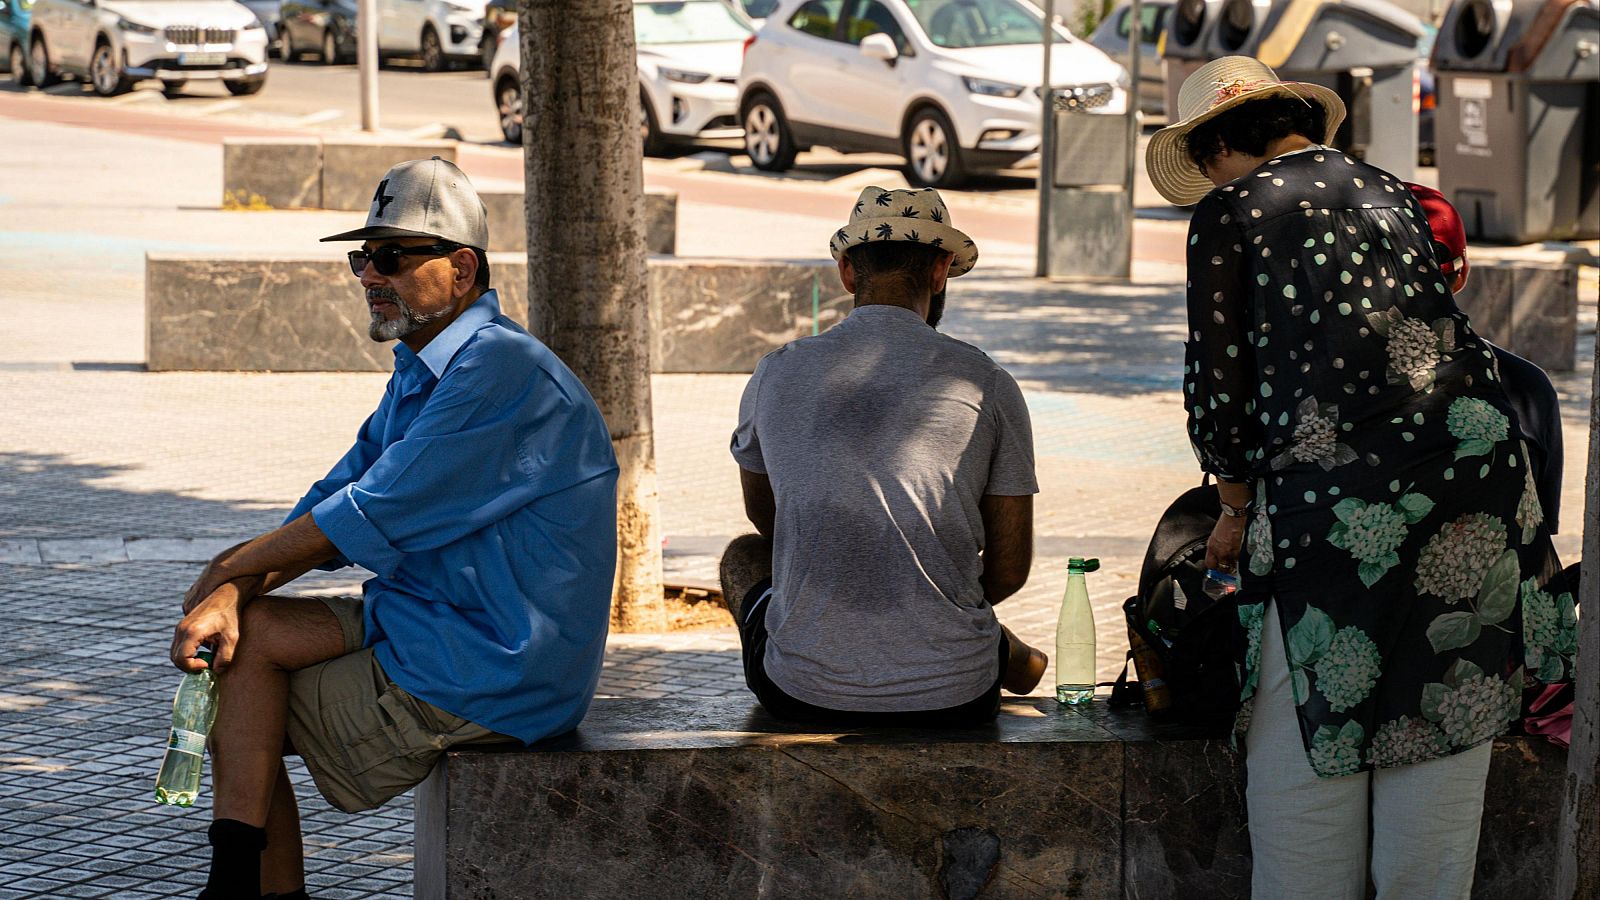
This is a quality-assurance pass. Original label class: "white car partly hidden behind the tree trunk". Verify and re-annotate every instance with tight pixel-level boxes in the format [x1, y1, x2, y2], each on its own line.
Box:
[491, 0, 754, 148]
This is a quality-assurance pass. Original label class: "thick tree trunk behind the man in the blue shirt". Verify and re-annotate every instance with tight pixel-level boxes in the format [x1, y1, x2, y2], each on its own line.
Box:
[520, 0, 666, 631]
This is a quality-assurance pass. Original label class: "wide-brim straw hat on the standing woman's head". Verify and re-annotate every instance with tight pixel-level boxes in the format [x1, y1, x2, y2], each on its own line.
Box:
[1144, 56, 1344, 207]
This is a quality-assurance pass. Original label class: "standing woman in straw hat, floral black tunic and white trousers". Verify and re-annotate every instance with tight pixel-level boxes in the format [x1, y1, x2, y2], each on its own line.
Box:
[1147, 56, 1541, 900]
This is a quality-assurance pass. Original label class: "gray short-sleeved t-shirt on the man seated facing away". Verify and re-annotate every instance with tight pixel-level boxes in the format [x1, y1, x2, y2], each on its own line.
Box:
[733, 304, 1038, 711]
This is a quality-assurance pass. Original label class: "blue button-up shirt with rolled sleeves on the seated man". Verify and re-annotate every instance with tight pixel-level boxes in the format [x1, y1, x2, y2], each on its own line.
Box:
[290, 291, 618, 743]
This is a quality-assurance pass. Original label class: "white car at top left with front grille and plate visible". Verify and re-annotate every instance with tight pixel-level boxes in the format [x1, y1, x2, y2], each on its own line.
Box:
[29, 0, 267, 96]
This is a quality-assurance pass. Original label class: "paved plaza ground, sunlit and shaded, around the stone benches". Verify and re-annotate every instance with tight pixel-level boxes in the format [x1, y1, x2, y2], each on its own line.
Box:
[0, 108, 1594, 900]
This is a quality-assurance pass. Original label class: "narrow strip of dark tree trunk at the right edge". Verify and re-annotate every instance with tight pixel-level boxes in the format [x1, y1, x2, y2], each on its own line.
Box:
[1554, 323, 1600, 900]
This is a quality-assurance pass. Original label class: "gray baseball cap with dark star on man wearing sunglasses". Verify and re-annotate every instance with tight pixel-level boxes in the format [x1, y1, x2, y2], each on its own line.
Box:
[323, 157, 490, 251]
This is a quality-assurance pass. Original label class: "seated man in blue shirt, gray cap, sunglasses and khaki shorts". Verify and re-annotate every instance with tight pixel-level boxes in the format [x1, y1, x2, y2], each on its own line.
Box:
[171, 157, 618, 900]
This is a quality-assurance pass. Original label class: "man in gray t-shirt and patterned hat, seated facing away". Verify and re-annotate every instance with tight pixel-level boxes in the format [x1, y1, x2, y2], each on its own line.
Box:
[722, 187, 1046, 724]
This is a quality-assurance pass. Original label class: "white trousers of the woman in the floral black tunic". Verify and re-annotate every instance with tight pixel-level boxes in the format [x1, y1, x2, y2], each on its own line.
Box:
[1245, 604, 1493, 900]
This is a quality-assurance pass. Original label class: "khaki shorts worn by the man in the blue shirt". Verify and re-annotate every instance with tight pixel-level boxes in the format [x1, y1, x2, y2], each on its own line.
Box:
[288, 597, 520, 812]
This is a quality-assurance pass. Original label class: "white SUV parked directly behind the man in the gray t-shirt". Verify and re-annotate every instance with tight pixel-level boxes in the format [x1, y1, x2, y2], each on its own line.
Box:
[739, 0, 1128, 187]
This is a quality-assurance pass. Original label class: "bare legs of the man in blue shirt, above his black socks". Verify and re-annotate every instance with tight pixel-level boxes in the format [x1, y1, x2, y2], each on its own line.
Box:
[211, 596, 344, 892]
